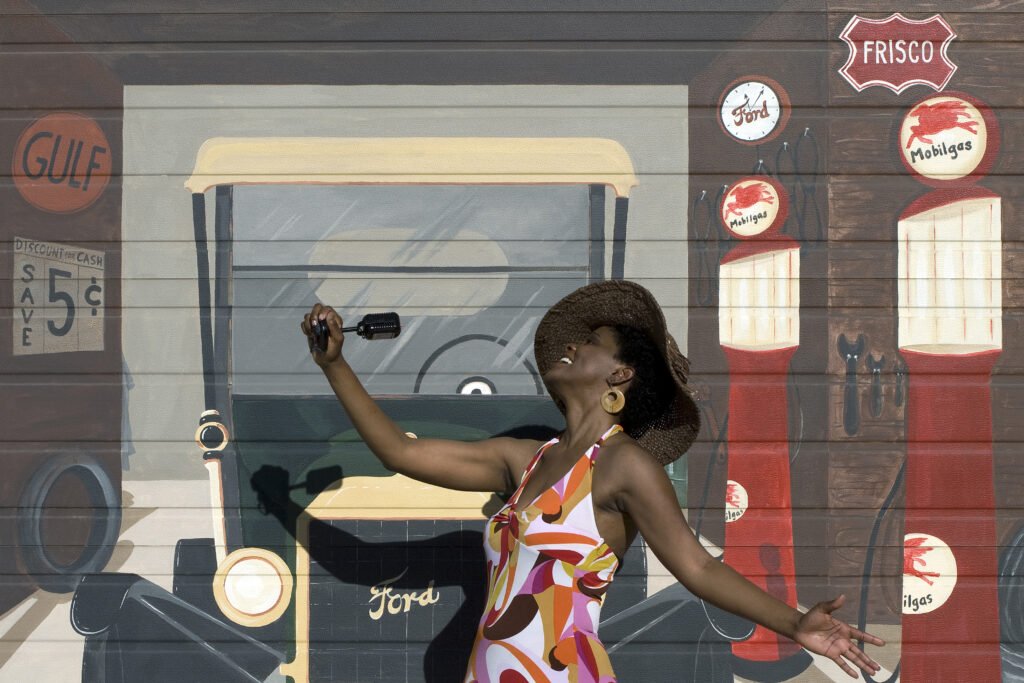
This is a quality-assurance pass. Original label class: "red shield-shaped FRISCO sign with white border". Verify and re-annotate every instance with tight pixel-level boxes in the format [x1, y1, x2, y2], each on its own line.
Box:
[839, 13, 956, 94]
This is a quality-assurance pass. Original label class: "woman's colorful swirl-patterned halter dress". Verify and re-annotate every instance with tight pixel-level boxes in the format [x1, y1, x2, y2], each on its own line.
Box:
[465, 425, 623, 683]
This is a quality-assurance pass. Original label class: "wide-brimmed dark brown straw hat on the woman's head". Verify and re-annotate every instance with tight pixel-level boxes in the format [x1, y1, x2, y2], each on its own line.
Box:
[534, 280, 700, 465]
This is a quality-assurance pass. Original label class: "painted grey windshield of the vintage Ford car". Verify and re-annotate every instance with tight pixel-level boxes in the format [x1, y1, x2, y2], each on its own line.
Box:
[231, 184, 591, 395]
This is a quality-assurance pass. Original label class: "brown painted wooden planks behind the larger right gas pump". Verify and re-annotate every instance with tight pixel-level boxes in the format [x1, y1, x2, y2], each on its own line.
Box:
[827, 3, 1022, 630]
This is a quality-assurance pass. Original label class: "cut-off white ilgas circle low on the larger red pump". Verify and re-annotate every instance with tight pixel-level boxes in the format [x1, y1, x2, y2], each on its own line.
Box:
[903, 533, 956, 614]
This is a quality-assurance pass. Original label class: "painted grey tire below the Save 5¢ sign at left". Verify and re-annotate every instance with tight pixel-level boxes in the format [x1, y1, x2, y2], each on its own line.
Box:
[17, 454, 121, 593]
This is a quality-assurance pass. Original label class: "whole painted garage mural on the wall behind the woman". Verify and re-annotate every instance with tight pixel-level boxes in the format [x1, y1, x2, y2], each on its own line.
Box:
[0, 0, 1024, 683]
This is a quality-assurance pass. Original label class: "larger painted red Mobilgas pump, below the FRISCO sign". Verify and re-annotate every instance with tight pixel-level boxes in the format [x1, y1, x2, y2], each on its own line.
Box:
[898, 93, 1002, 683]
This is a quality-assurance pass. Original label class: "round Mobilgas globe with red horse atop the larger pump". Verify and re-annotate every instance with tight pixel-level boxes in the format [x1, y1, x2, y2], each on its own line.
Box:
[899, 93, 996, 184]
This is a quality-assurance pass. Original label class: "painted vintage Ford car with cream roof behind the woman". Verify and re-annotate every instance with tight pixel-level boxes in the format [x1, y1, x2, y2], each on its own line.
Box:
[73, 138, 708, 682]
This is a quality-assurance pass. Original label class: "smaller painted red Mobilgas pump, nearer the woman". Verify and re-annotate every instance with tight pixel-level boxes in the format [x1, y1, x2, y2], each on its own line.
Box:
[719, 176, 800, 663]
